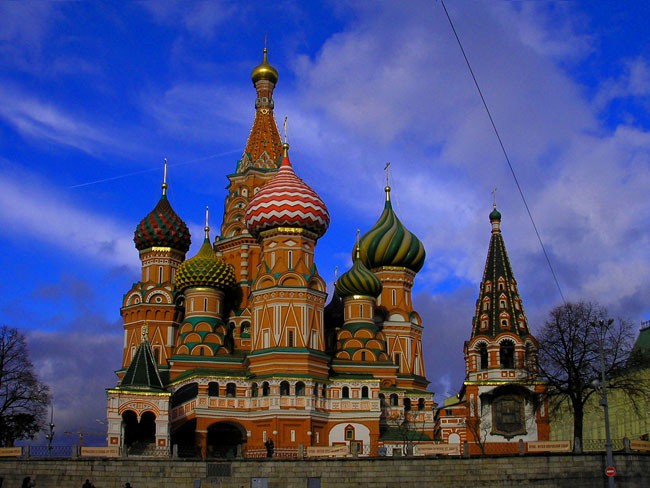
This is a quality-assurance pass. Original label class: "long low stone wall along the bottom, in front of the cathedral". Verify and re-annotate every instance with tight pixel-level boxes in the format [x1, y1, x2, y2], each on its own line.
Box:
[0, 454, 650, 488]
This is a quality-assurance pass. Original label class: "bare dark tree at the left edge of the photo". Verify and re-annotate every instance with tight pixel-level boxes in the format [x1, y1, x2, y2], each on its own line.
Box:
[0, 325, 50, 447]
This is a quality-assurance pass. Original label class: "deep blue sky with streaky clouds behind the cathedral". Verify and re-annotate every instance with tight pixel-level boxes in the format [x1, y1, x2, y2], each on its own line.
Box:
[0, 0, 650, 441]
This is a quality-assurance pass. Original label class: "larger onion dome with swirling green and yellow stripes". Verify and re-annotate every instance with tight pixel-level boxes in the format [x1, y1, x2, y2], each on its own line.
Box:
[359, 186, 426, 273]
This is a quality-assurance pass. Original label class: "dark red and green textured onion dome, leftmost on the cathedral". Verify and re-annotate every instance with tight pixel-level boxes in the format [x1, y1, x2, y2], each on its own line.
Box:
[133, 192, 192, 253]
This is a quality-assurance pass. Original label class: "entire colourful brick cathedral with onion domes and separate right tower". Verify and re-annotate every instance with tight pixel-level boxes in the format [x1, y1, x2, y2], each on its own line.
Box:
[107, 49, 548, 458]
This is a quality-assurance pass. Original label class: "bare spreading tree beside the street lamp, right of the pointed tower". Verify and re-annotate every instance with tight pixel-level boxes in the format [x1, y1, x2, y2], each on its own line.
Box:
[537, 301, 647, 441]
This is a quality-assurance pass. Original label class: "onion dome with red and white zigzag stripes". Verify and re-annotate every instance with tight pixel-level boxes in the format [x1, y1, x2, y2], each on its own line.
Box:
[246, 143, 330, 237]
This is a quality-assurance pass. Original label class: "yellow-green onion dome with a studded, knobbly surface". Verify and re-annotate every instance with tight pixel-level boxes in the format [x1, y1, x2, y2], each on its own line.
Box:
[176, 232, 236, 290]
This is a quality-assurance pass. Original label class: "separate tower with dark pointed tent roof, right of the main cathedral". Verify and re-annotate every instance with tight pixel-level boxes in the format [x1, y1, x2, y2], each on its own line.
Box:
[450, 201, 549, 452]
